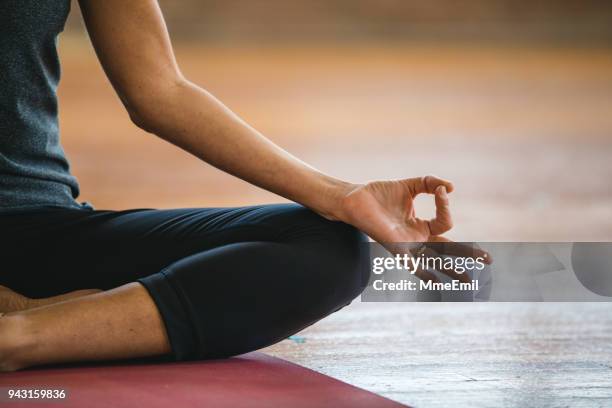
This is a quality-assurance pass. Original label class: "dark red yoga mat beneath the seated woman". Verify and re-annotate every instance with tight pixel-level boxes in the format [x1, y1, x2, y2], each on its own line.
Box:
[0, 352, 412, 408]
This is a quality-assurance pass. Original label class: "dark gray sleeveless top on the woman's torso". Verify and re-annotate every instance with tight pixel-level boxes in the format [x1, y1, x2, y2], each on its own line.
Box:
[0, 0, 83, 210]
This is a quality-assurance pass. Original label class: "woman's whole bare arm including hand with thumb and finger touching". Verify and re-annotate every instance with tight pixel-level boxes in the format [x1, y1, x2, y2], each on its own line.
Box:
[80, 0, 460, 252]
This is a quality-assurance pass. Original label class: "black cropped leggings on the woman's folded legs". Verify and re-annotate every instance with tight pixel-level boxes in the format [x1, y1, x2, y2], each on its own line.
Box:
[0, 204, 367, 360]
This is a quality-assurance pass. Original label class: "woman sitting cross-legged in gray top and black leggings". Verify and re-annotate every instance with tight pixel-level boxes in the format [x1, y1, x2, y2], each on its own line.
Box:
[0, 0, 460, 371]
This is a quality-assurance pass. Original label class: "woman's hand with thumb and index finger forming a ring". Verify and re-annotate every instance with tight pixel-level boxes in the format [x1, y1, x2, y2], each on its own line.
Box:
[339, 176, 453, 245]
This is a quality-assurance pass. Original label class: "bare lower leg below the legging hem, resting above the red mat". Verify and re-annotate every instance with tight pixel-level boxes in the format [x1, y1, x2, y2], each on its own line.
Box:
[0, 282, 172, 370]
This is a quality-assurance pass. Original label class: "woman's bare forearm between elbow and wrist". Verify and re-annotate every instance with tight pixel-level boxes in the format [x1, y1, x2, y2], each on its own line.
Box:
[132, 80, 353, 219]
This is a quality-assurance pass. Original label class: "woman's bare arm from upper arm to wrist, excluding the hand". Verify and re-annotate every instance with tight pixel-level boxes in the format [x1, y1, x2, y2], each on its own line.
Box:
[81, 0, 351, 218]
